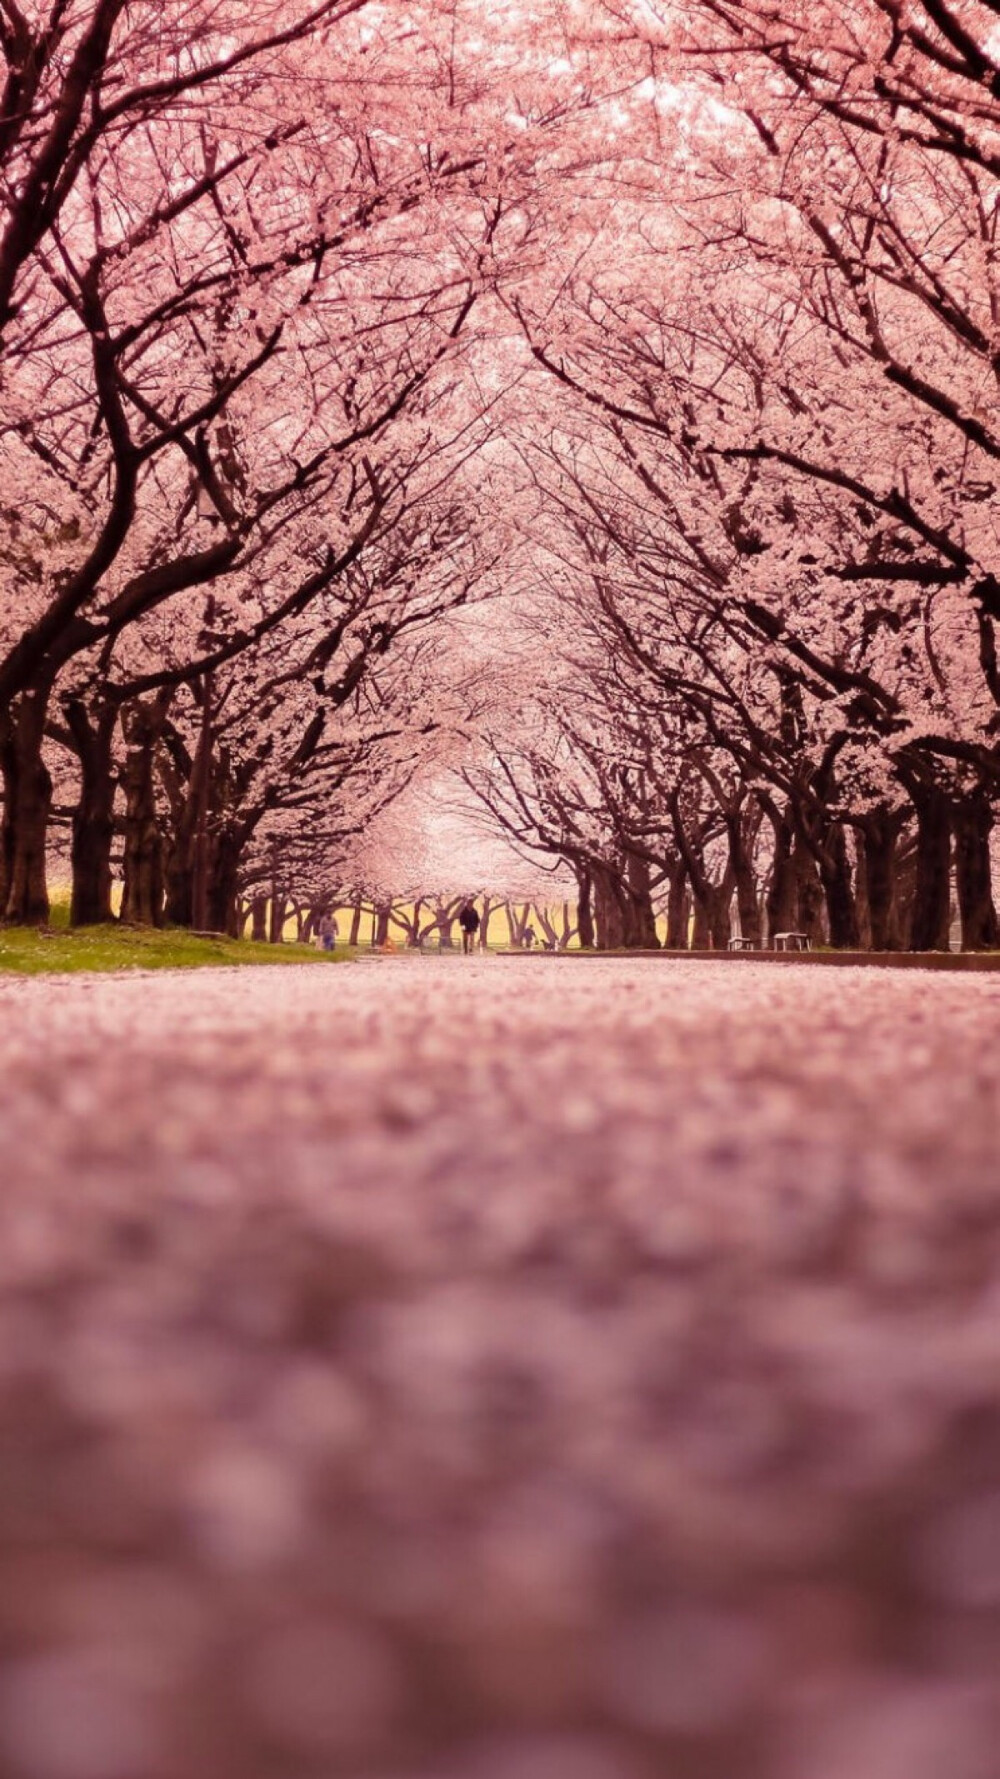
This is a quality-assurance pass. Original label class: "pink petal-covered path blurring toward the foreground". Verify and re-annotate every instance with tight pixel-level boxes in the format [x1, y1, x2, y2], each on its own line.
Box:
[0, 957, 1000, 1779]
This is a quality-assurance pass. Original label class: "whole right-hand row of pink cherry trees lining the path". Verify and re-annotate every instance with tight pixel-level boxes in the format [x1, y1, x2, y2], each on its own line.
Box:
[462, 0, 1000, 950]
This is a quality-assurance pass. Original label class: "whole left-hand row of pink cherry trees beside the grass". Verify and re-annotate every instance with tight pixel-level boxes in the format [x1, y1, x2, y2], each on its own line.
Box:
[0, 0, 576, 930]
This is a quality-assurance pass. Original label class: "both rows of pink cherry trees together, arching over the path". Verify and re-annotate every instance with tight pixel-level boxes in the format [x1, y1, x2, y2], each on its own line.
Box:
[0, 0, 1000, 950]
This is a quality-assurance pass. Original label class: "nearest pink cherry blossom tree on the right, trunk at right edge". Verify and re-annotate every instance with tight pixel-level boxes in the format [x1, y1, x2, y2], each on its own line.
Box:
[516, 4, 996, 946]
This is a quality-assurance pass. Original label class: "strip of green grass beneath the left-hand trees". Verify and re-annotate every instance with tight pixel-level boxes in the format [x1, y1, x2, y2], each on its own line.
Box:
[0, 925, 345, 977]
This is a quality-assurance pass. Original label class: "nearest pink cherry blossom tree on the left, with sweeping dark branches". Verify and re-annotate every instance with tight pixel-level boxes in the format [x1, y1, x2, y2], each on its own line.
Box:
[0, 0, 590, 920]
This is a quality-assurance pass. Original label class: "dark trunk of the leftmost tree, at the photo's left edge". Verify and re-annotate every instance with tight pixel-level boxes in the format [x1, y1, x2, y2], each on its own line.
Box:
[4, 683, 52, 927]
